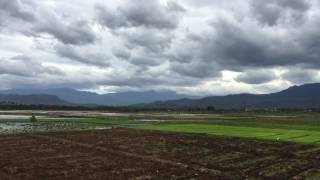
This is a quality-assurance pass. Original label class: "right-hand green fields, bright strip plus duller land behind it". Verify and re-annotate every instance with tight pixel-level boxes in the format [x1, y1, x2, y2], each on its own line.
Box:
[133, 113, 320, 144]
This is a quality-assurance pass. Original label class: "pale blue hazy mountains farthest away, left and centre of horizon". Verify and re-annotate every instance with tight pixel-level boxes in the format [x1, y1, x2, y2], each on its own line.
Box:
[0, 88, 194, 106]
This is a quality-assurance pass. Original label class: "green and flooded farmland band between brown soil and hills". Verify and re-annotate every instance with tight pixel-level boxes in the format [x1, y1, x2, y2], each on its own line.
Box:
[0, 111, 320, 144]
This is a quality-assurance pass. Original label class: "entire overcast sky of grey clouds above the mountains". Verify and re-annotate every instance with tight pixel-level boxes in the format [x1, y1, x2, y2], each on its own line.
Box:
[0, 0, 320, 95]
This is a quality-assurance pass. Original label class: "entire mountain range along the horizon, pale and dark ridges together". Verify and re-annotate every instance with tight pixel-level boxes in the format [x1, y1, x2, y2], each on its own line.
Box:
[0, 83, 320, 109]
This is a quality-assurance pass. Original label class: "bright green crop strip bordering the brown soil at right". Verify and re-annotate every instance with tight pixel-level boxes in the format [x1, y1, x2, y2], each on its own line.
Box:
[137, 124, 320, 144]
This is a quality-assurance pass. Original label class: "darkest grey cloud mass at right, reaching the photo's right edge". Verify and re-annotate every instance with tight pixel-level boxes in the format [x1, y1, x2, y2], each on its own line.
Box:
[210, 4, 320, 69]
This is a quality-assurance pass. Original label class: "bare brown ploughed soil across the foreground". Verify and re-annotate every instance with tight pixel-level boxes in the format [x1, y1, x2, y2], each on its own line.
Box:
[0, 129, 320, 180]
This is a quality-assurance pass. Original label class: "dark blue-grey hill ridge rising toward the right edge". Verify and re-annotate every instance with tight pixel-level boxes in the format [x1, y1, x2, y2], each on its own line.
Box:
[137, 83, 320, 109]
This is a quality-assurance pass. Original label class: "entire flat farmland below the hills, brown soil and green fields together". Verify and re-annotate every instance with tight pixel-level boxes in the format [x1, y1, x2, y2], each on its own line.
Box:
[0, 111, 320, 179]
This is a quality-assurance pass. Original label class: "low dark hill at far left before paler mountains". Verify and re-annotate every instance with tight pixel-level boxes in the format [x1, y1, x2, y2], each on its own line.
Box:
[0, 94, 72, 106]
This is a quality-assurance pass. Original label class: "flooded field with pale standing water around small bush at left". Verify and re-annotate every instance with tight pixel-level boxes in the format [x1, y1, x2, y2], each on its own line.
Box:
[0, 111, 117, 134]
